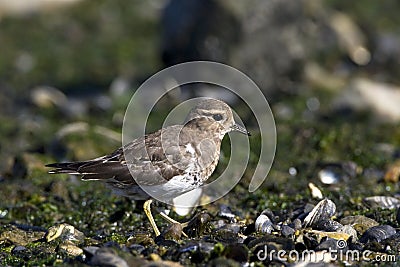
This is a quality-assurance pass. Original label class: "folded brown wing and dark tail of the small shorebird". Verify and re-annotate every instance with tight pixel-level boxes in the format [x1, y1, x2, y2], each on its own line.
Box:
[46, 126, 190, 185]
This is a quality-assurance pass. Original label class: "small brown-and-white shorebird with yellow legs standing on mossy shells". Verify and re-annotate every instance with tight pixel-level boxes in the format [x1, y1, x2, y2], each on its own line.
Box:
[46, 98, 250, 236]
